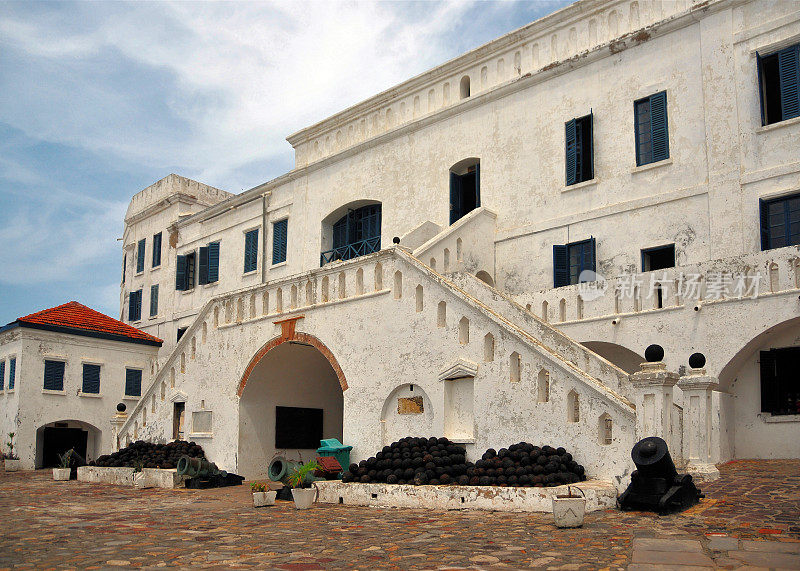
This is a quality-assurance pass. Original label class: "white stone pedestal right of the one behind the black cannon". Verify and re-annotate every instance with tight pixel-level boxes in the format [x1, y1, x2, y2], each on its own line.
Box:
[678, 369, 719, 480]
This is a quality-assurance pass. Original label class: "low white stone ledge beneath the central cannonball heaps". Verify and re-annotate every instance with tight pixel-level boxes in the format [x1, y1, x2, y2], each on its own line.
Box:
[316, 480, 617, 513]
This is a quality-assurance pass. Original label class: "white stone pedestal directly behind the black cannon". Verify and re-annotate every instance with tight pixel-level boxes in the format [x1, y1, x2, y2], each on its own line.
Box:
[630, 361, 681, 442]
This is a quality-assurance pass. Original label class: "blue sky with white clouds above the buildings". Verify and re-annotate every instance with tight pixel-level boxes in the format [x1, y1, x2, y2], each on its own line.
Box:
[0, 0, 569, 324]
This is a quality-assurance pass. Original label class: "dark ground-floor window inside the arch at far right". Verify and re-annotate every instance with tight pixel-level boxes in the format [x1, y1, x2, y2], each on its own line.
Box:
[760, 347, 800, 415]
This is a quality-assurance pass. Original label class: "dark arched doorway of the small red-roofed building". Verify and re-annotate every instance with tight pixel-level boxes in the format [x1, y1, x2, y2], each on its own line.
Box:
[36, 420, 102, 468]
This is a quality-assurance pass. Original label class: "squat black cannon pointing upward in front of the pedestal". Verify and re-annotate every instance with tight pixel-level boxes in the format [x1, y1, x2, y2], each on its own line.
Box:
[617, 436, 705, 515]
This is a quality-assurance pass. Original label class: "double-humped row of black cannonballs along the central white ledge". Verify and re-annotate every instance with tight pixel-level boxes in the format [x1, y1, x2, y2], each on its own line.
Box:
[342, 437, 586, 487]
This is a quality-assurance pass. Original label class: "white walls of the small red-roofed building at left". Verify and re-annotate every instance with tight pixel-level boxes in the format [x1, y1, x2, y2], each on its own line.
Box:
[0, 326, 159, 470]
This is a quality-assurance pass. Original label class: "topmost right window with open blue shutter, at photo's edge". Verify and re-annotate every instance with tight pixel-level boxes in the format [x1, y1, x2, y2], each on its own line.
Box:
[756, 44, 800, 125]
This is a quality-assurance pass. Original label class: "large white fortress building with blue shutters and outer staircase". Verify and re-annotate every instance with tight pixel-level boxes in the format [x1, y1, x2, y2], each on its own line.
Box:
[7, 0, 800, 484]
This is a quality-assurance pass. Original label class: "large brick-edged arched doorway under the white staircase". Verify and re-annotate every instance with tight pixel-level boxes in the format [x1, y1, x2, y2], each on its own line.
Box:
[237, 340, 346, 479]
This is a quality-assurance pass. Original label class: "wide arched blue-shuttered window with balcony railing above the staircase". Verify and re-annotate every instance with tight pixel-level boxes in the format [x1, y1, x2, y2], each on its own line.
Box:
[320, 204, 381, 265]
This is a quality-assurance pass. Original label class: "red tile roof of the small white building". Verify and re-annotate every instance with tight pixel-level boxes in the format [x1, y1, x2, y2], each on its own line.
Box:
[16, 301, 163, 346]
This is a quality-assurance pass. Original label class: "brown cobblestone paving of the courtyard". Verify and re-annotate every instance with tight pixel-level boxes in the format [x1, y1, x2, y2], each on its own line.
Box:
[0, 461, 800, 570]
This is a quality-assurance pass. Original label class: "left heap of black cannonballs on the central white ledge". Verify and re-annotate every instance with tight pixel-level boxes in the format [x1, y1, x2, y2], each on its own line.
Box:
[342, 437, 472, 486]
